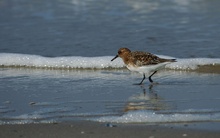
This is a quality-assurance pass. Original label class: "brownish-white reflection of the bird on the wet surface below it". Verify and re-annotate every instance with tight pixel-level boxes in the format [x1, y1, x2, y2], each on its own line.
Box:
[124, 85, 169, 112]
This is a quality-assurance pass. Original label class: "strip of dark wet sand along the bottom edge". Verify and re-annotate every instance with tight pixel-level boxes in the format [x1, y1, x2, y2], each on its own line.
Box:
[0, 121, 220, 138]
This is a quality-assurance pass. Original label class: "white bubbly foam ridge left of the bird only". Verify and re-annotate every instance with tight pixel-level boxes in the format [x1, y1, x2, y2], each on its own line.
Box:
[0, 53, 123, 69]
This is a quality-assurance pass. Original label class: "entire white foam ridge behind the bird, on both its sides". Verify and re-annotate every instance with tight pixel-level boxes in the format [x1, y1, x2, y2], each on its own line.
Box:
[0, 53, 220, 70]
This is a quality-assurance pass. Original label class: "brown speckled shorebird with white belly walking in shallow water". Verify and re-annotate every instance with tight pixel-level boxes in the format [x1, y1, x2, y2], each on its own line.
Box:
[111, 48, 176, 85]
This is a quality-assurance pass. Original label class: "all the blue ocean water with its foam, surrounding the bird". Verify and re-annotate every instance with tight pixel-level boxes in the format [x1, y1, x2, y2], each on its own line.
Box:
[0, 0, 220, 130]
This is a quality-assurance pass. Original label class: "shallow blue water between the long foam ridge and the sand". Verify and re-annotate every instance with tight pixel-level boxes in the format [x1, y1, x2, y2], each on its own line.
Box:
[0, 68, 220, 127]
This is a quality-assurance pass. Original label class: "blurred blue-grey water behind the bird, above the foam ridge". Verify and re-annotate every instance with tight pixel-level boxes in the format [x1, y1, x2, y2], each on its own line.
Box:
[0, 0, 220, 57]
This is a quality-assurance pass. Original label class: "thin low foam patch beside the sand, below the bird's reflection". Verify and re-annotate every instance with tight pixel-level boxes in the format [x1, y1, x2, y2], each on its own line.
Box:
[92, 110, 220, 123]
